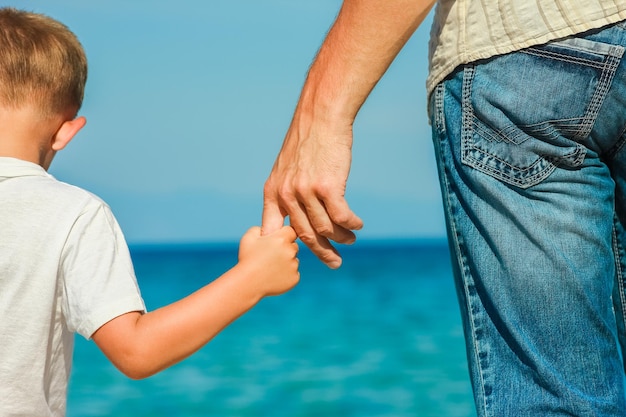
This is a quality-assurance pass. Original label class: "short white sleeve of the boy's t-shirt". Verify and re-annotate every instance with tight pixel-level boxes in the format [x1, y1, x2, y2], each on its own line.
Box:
[60, 200, 145, 339]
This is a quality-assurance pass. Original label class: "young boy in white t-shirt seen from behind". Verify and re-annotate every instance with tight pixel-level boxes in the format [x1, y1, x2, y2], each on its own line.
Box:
[0, 8, 299, 416]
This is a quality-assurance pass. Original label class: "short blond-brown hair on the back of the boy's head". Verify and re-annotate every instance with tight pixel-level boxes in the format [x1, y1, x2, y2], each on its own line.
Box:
[0, 7, 87, 116]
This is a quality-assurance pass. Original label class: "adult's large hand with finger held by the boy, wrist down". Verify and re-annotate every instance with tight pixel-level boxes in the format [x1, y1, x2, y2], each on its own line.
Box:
[263, 118, 363, 268]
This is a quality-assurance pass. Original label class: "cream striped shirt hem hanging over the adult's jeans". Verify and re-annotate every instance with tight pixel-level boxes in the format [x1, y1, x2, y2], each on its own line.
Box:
[426, 0, 626, 93]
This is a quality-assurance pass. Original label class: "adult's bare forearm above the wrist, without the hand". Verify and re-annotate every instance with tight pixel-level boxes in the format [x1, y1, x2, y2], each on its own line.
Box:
[296, 0, 434, 125]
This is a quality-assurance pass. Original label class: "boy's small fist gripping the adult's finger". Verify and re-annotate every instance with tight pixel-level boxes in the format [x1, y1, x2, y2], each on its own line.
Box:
[239, 226, 300, 297]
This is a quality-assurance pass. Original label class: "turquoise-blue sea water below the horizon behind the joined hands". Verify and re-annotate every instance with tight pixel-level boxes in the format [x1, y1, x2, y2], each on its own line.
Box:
[68, 241, 475, 417]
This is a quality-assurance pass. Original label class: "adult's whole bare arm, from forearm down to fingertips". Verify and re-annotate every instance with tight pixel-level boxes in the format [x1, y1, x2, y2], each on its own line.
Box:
[262, 0, 435, 268]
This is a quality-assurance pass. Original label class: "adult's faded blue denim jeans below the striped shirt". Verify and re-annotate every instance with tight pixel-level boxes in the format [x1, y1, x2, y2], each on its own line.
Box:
[430, 23, 626, 417]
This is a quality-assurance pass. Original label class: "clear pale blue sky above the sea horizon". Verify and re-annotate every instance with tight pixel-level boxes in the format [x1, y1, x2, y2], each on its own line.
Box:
[15, 0, 444, 244]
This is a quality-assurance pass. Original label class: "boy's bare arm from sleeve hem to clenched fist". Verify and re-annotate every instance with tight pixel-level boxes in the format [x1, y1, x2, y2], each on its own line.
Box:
[92, 227, 299, 379]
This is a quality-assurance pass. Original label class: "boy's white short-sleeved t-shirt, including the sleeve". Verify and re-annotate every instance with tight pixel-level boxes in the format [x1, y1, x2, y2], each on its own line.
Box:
[0, 157, 145, 417]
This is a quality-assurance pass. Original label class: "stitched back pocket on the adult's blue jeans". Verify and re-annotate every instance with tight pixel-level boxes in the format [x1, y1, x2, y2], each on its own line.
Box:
[461, 38, 624, 188]
